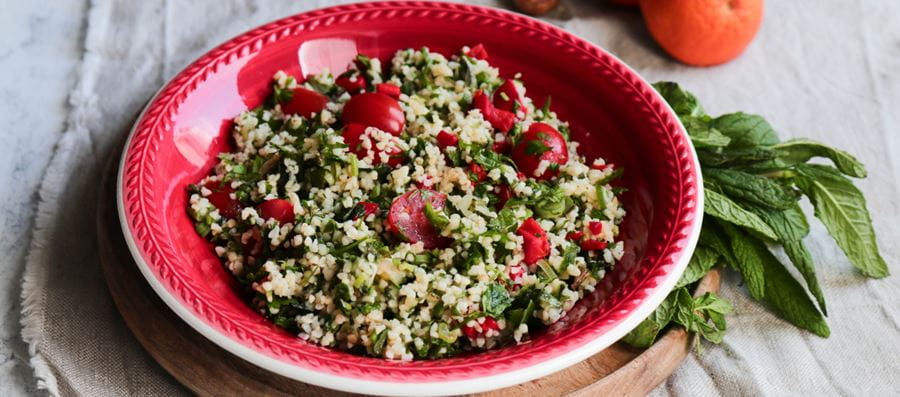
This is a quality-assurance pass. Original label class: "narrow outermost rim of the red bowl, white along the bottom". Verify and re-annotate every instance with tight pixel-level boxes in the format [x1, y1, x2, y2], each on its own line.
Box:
[116, 1, 704, 396]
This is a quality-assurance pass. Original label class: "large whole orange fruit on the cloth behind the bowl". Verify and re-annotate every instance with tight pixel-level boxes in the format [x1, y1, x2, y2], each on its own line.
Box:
[641, 0, 763, 66]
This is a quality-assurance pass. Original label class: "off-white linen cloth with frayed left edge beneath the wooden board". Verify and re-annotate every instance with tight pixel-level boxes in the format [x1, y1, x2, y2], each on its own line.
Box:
[22, 0, 900, 396]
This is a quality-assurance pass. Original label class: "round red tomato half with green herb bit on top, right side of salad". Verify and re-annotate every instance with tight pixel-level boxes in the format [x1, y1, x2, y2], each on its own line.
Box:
[512, 123, 569, 180]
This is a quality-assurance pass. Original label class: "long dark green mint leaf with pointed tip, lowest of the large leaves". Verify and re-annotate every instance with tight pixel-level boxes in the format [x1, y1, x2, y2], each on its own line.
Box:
[762, 244, 831, 338]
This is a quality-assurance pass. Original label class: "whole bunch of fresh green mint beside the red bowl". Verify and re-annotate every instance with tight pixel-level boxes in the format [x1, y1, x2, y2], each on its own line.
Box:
[623, 82, 888, 347]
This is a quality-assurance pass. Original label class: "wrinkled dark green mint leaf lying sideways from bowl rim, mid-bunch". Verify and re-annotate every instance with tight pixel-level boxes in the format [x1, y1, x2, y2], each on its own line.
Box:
[703, 168, 799, 209]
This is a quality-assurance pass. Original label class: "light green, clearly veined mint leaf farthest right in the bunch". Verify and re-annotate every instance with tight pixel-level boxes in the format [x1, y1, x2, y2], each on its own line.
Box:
[797, 164, 889, 278]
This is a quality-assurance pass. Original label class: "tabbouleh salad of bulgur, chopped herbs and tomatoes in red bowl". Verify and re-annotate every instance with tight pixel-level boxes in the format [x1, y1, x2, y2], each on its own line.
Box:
[188, 45, 625, 360]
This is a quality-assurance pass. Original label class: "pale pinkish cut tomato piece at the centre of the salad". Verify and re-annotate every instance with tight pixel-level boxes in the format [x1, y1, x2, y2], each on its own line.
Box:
[387, 189, 451, 249]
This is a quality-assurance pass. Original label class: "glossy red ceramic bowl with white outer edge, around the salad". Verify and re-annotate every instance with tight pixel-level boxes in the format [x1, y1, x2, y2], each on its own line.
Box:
[118, 2, 703, 395]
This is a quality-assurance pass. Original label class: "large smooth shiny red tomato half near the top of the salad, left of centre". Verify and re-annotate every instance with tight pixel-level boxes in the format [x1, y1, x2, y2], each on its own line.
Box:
[341, 92, 406, 136]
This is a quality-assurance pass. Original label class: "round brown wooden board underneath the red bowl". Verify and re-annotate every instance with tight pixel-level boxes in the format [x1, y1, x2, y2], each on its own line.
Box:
[97, 146, 719, 396]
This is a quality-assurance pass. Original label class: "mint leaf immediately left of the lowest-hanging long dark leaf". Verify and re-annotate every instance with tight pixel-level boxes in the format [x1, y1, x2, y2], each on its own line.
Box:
[722, 223, 771, 300]
